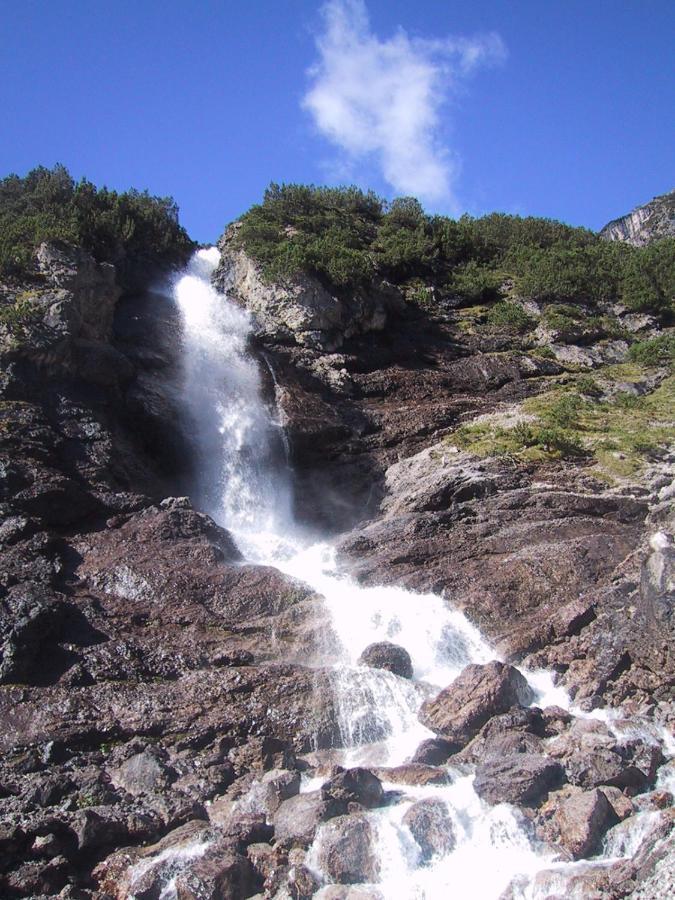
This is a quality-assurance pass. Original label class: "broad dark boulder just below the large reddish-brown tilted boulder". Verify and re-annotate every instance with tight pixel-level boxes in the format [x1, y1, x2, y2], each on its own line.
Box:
[474, 753, 565, 806]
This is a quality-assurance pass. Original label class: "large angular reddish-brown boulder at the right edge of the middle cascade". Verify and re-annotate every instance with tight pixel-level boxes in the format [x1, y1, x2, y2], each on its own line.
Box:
[419, 662, 534, 746]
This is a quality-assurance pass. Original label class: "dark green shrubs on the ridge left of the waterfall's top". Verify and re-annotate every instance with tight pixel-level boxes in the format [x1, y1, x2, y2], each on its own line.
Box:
[0, 165, 194, 278]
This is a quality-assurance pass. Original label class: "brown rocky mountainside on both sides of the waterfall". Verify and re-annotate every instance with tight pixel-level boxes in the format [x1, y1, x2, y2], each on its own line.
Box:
[0, 216, 675, 900]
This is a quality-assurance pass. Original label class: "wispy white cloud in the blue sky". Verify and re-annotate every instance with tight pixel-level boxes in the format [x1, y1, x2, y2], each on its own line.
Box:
[302, 0, 506, 208]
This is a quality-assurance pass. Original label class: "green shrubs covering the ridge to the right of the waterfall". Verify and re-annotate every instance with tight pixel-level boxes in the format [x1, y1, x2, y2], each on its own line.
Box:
[235, 184, 675, 314]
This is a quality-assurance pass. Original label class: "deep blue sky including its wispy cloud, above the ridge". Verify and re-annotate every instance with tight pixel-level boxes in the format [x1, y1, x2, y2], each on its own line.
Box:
[0, 0, 675, 241]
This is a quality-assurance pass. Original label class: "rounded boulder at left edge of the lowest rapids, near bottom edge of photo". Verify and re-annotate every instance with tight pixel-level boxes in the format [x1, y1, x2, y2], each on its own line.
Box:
[318, 815, 379, 884]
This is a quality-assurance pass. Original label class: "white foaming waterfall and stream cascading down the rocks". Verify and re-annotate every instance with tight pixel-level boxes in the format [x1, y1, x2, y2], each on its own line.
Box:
[174, 248, 672, 900]
